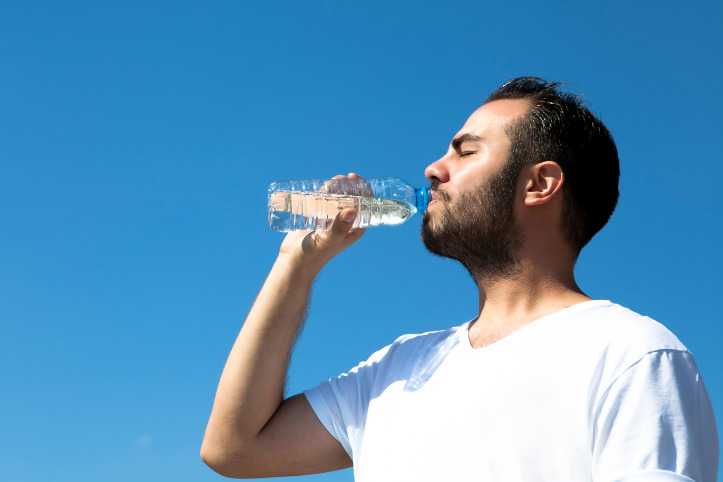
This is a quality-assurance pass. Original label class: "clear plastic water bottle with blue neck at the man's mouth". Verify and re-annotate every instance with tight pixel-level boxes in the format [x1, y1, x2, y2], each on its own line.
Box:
[269, 177, 431, 232]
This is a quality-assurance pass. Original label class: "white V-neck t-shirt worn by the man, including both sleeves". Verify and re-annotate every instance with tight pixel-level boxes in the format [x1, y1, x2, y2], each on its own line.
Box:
[304, 301, 718, 482]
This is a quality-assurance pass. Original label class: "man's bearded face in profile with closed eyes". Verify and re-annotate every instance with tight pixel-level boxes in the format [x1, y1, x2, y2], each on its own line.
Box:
[422, 100, 529, 277]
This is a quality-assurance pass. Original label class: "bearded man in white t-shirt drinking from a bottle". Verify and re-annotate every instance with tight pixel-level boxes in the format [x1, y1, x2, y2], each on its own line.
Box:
[201, 78, 718, 482]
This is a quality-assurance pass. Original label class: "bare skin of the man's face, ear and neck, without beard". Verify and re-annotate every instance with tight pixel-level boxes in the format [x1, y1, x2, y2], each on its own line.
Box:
[425, 99, 590, 348]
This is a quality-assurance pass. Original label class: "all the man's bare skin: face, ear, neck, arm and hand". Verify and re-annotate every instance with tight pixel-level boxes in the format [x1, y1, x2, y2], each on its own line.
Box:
[201, 99, 590, 478]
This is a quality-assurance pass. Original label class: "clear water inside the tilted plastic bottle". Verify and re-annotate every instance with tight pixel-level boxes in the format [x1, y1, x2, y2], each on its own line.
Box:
[269, 191, 417, 231]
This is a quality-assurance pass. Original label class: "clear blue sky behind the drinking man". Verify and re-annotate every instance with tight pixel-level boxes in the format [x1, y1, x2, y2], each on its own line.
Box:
[0, 0, 723, 482]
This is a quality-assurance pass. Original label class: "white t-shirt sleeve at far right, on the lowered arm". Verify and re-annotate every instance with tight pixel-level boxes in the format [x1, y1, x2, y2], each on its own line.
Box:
[593, 350, 718, 482]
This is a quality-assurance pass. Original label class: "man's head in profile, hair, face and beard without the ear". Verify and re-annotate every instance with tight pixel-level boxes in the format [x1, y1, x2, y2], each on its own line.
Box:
[422, 77, 619, 274]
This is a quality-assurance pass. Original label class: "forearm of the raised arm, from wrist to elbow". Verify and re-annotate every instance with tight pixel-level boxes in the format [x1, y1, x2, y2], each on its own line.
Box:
[204, 255, 316, 451]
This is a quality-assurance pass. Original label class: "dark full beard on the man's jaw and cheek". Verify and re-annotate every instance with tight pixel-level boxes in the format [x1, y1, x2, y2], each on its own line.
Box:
[421, 162, 522, 282]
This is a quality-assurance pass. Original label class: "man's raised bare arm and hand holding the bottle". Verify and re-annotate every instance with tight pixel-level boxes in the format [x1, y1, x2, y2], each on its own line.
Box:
[201, 186, 363, 478]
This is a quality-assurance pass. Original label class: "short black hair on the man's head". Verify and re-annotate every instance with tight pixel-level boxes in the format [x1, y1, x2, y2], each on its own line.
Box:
[485, 77, 620, 255]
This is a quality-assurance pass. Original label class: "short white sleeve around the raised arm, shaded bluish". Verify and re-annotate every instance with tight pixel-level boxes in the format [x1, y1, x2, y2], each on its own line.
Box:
[304, 345, 391, 457]
